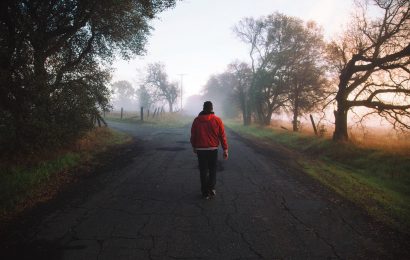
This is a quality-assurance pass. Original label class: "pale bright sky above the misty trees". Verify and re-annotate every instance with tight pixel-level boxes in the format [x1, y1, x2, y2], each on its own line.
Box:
[112, 0, 353, 107]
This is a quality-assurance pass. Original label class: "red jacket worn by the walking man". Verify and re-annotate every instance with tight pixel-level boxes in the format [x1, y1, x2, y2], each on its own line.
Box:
[191, 112, 228, 150]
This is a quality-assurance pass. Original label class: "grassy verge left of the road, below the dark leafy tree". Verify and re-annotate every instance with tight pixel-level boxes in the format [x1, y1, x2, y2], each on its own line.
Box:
[0, 128, 131, 220]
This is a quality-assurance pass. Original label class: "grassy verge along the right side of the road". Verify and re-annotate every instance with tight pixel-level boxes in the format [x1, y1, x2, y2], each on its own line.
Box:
[227, 122, 410, 233]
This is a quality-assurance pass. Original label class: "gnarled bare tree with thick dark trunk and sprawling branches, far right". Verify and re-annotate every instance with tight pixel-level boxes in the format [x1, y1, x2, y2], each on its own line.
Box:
[329, 0, 410, 141]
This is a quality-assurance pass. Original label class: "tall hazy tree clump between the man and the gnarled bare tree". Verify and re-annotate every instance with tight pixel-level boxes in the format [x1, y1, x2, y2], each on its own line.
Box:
[234, 13, 324, 127]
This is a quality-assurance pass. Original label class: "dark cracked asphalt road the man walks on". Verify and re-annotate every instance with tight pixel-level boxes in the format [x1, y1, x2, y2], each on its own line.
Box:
[2, 122, 408, 259]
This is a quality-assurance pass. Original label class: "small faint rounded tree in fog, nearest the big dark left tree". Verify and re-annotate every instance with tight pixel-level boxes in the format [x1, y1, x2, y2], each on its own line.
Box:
[112, 80, 136, 110]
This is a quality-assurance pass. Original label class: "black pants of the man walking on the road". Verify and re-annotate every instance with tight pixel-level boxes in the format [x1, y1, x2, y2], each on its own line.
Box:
[197, 149, 218, 196]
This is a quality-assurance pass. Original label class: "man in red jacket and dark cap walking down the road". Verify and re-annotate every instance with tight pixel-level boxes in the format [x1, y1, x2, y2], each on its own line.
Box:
[191, 101, 228, 199]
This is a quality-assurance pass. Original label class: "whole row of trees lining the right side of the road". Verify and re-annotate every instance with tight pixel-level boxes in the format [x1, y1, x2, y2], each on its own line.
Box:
[205, 0, 410, 141]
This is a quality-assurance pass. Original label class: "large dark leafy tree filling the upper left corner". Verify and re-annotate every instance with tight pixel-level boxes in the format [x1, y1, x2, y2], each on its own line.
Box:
[0, 0, 175, 150]
